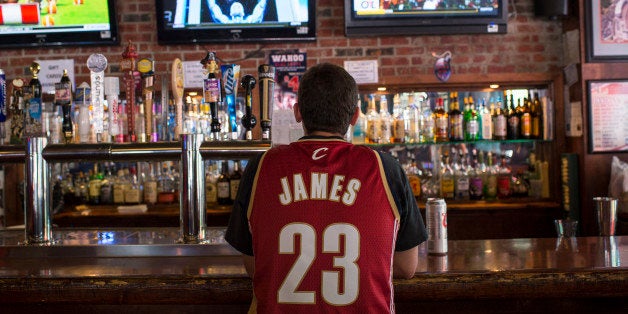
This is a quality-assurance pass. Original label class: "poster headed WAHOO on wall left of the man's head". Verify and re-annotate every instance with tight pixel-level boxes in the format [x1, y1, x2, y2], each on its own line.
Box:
[268, 50, 307, 145]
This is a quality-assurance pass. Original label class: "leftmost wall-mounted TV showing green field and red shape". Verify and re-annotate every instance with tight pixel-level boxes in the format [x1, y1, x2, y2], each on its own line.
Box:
[0, 0, 119, 48]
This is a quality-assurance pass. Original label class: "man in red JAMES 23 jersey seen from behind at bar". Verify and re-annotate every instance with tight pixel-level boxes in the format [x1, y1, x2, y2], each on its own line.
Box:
[225, 63, 427, 313]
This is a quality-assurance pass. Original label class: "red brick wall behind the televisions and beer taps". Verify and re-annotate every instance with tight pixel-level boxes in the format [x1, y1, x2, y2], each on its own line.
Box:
[0, 0, 562, 86]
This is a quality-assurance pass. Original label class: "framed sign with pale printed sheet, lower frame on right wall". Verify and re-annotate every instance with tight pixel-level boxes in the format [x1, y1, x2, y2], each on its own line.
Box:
[587, 79, 628, 153]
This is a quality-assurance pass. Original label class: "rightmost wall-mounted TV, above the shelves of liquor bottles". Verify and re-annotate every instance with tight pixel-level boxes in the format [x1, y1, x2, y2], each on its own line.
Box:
[344, 0, 508, 37]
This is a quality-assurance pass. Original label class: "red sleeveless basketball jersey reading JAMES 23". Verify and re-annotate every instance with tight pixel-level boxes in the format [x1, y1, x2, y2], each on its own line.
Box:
[248, 139, 399, 313]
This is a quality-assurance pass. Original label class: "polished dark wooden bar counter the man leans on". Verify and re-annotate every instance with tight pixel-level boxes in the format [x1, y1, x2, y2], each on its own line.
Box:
[0, 228, 628, 313]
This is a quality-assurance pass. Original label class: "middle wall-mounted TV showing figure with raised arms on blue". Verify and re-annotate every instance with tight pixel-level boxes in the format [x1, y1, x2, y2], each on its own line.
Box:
[155, 0, 316, 44]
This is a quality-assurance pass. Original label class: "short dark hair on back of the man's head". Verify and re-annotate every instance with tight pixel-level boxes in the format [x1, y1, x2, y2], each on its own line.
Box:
[297, 63, 358, 134]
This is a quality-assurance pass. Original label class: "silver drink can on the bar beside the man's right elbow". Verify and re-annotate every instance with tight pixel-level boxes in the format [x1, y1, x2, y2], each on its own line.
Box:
[425, 198, 447, 255]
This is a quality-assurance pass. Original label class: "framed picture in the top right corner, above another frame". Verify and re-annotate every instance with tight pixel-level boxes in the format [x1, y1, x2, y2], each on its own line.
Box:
[584, 0, 628, 62]
